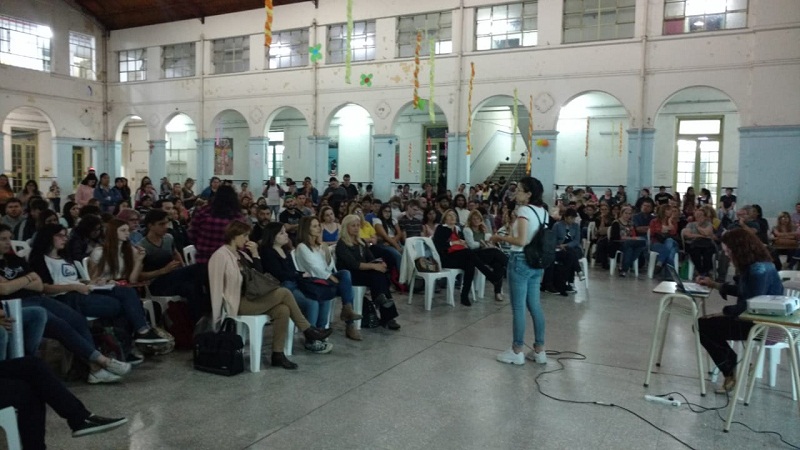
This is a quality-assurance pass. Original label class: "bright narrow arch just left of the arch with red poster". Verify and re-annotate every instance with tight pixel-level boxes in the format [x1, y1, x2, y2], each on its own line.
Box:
[164, 113, 197, 187]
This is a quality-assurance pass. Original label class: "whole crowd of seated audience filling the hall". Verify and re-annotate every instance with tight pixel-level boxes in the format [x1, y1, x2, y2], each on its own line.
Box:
[0, 171, 800, 446]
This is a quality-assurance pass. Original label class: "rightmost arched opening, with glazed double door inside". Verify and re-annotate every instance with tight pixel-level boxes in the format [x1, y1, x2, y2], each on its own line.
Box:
[653, 86, 740, 204]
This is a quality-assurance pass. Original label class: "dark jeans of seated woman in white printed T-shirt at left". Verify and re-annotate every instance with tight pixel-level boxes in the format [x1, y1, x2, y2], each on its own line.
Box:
[56, 286, 149, 331]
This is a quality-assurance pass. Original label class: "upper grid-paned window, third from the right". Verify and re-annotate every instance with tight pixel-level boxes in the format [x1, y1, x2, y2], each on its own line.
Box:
[475, 2, 539, 50]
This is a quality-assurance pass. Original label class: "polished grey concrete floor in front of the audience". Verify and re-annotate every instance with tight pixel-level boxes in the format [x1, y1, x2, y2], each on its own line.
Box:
[42, 269, 800, 450]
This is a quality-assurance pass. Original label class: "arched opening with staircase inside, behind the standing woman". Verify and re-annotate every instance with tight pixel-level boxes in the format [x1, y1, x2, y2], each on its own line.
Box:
[470, 95, 530, 184]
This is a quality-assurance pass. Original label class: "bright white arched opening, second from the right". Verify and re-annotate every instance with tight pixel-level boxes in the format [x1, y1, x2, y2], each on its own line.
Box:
[554, 91, 629, 188]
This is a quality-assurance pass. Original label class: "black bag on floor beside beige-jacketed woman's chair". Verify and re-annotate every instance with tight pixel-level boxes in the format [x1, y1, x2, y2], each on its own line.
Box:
[194, 318, 244, 377]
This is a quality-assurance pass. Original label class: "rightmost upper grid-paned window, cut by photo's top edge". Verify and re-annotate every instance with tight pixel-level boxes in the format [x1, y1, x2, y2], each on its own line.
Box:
[664, 0, 747, 34]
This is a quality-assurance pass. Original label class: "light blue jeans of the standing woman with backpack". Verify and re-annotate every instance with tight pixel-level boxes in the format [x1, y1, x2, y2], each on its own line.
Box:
[508, 252, 545, 348]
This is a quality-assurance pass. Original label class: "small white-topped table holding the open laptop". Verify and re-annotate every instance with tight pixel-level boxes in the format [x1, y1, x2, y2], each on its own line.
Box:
[644, 281, 710, 396]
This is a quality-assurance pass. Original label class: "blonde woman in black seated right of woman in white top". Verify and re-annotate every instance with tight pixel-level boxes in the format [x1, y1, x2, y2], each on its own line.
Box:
[336, 214, 400, 330]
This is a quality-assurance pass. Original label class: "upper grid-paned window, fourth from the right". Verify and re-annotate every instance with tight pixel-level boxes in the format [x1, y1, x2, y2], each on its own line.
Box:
[397, 11, 453, 58]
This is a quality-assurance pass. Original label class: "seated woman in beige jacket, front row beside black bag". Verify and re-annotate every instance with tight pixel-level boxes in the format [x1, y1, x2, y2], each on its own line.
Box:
[208, 220, 331, 370]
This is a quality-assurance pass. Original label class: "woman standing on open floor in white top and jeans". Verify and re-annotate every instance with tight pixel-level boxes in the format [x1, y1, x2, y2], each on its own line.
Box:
[491, 177, 550, 365]
